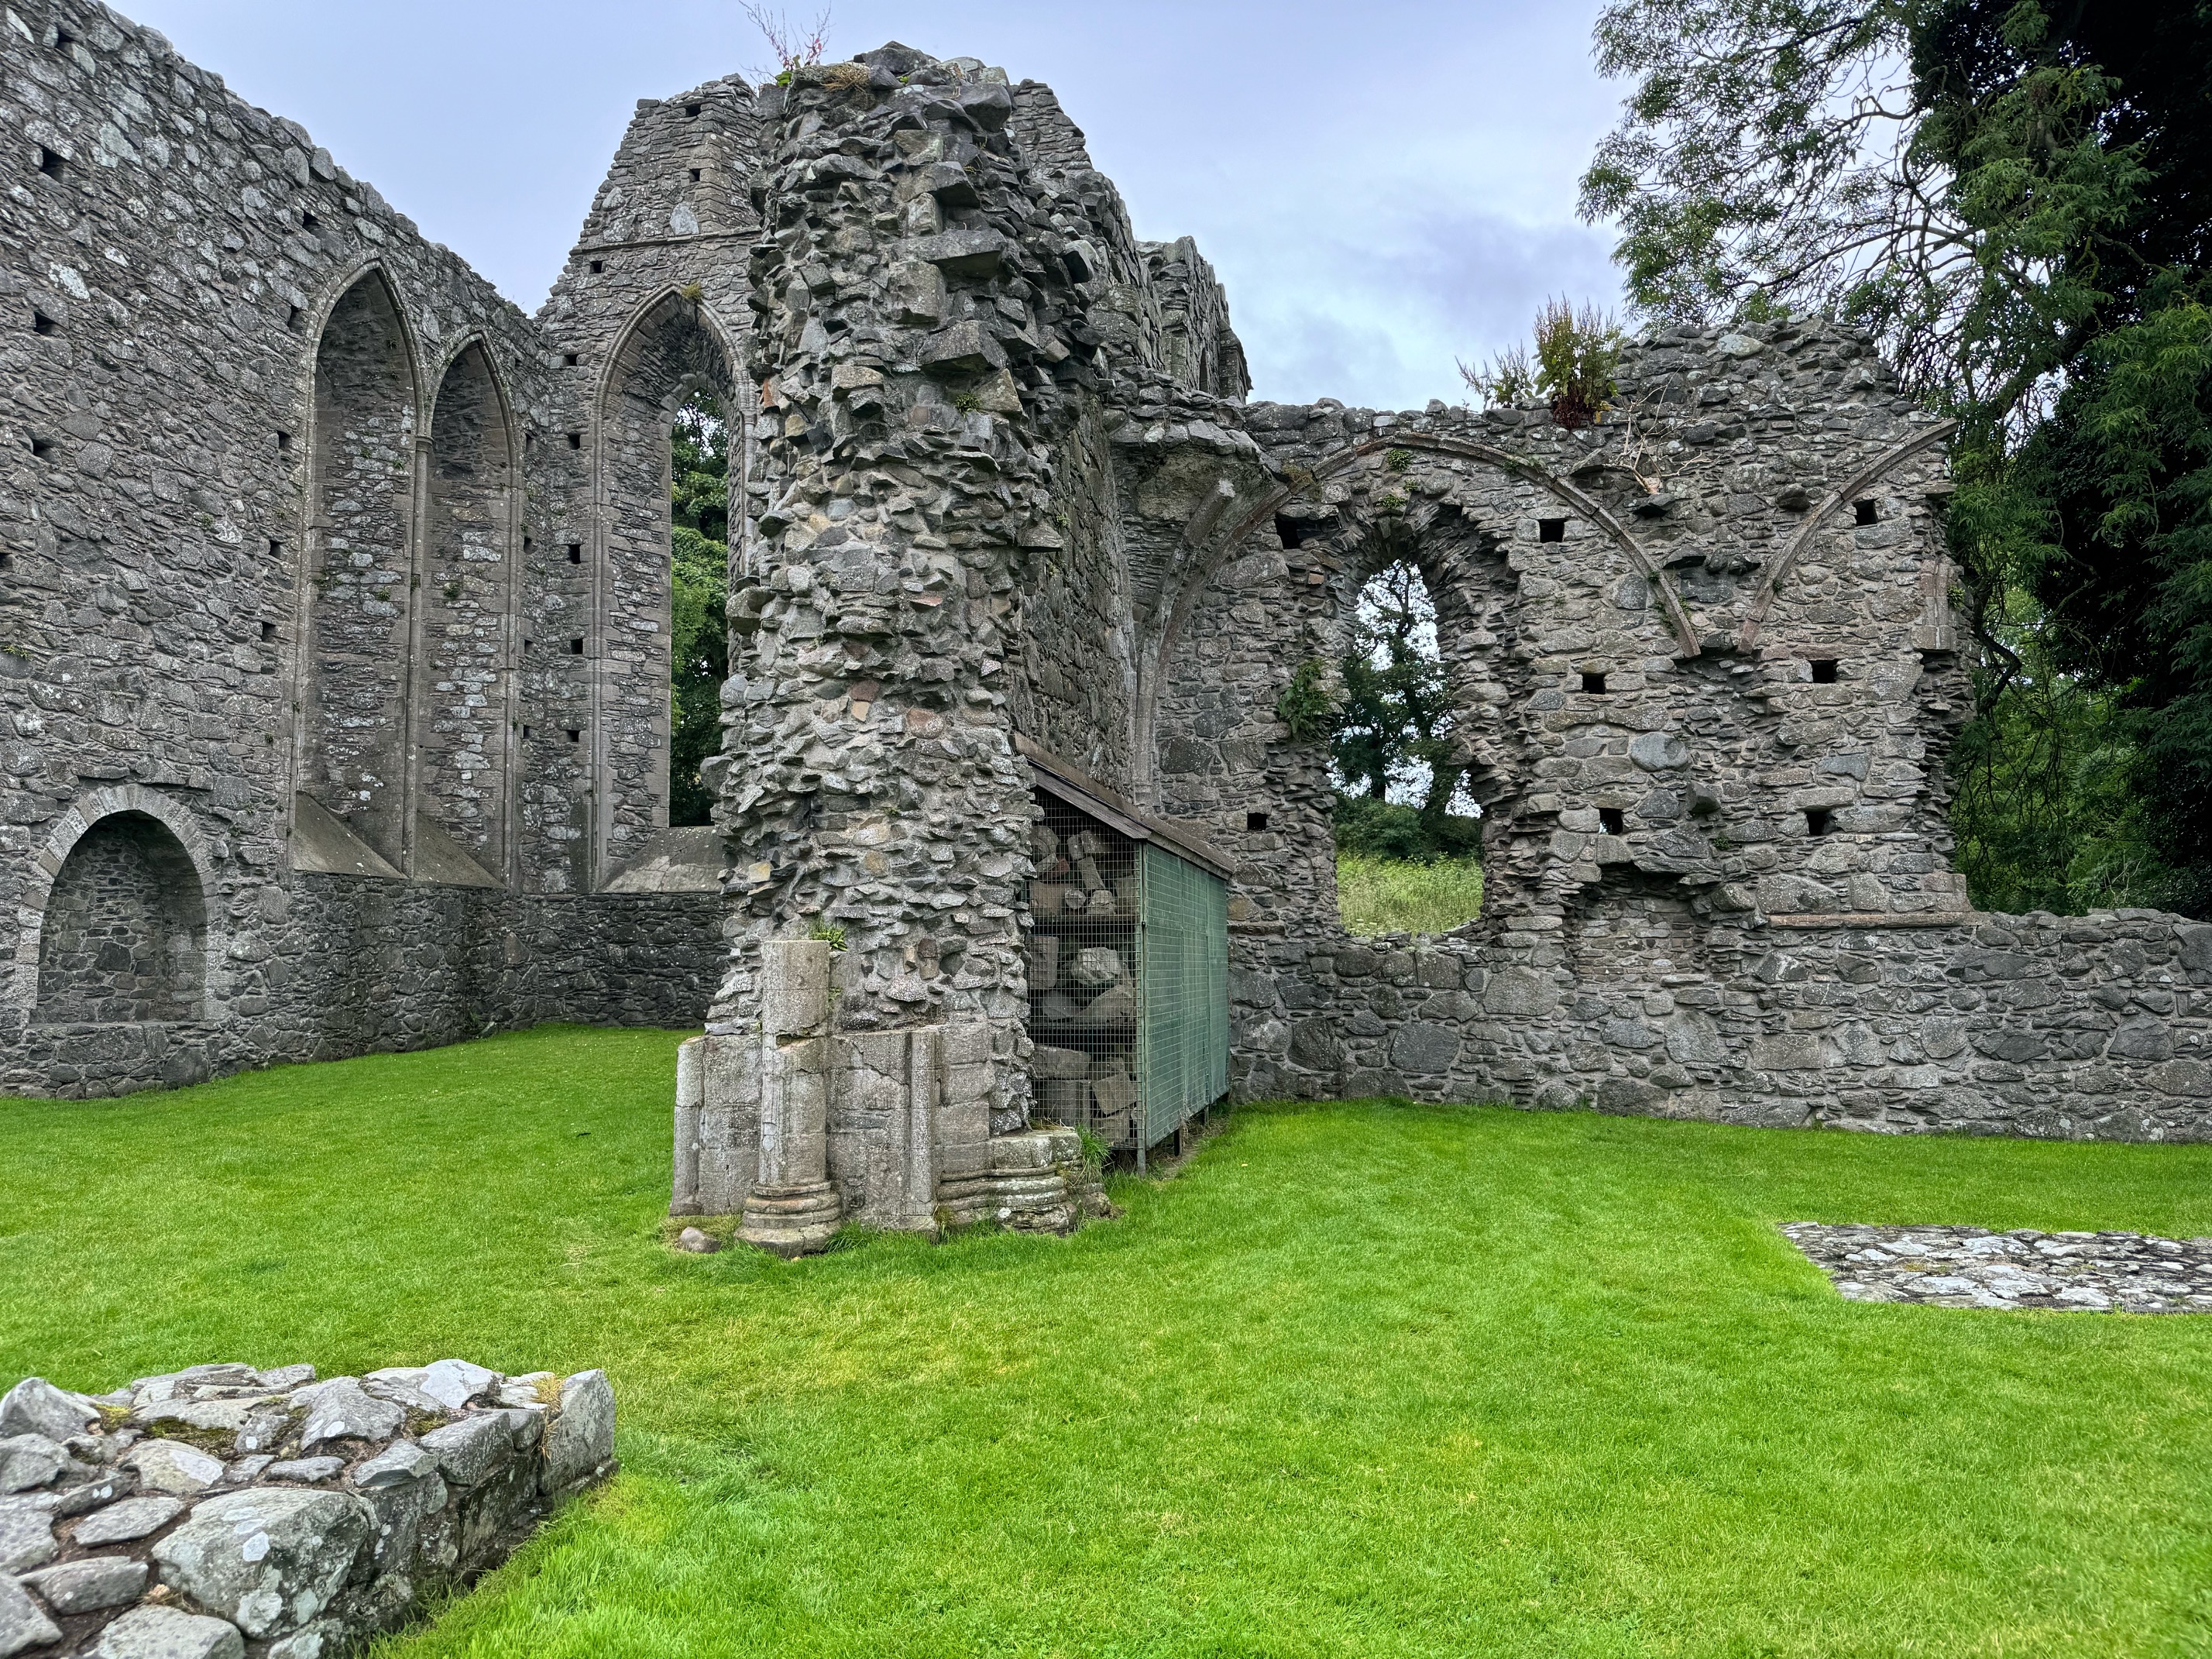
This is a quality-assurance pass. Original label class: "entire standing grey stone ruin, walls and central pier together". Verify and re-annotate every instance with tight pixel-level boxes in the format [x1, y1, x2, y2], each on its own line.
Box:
[0, 5, 2212, 1194]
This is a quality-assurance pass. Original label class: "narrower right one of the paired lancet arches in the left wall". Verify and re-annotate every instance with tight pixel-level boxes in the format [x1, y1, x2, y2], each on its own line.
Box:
[414, 338, 522, 881]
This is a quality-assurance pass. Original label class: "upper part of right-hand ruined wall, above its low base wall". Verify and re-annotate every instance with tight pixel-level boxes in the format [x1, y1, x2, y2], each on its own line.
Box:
[1159, 314, 1962, 937]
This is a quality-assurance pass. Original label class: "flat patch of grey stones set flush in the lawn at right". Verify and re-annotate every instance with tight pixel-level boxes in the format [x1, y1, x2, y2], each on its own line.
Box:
[1783, 1221, 2212, 1314]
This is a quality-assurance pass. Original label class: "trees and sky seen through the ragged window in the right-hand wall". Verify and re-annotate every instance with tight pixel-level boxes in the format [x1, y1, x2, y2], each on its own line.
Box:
[1329, 560, 1478, 858]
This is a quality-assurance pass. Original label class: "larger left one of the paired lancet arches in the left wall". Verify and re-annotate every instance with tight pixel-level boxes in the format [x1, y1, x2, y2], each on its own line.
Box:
[297, 263, 421, 867]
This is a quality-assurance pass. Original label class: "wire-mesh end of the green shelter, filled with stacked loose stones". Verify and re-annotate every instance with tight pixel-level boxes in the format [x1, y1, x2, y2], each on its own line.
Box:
[1029, 794, 1144, 1148]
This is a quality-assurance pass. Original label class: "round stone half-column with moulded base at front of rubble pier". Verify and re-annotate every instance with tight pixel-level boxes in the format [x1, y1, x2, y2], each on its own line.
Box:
[739, 940, 845, 1256]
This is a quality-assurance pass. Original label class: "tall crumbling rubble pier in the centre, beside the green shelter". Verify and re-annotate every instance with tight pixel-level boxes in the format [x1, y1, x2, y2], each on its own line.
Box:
[677, 46, 1283, 1225]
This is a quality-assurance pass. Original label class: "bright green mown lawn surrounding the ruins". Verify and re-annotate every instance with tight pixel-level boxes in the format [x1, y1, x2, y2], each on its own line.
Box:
[0, 1031, 2212, 1659]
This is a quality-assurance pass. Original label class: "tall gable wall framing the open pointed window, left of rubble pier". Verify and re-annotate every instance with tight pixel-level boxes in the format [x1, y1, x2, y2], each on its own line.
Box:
[524, 77, 761, 891]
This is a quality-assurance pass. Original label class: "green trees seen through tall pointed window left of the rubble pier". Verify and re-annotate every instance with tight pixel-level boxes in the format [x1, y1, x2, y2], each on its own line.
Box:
[668, 392, 730, 825]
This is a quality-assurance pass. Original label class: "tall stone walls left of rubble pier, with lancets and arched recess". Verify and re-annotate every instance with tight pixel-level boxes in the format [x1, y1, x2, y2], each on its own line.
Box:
[0, 5, 734, 1095]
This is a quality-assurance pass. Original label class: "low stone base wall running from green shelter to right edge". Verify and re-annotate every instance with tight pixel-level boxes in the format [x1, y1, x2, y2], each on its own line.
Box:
[1232, 912, 2212, 1142]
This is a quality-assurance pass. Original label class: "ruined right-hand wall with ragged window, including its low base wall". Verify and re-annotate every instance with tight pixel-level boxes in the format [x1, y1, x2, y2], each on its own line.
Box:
[1159, 328, 2212, 1139]
